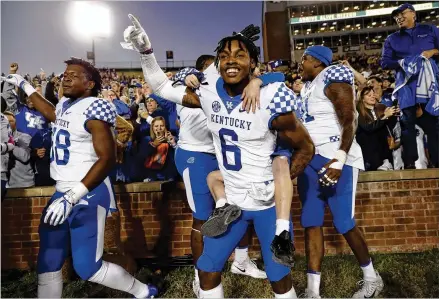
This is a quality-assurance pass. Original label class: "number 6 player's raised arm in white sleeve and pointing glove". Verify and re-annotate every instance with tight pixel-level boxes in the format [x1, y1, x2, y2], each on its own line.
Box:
[121, 14, 201, 108]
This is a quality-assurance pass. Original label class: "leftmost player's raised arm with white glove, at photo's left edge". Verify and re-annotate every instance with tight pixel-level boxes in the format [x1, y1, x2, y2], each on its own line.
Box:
[1, 74, 56, 122]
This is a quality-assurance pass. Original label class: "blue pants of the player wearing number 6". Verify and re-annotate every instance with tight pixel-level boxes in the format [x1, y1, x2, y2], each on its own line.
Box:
[197, 207, 292, 282]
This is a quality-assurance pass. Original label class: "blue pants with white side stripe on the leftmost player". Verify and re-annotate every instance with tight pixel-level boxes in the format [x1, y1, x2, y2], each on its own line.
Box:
[37, 178, 114, 280]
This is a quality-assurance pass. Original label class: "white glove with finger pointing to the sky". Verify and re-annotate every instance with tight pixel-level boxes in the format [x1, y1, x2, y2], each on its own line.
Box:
[120, 14, 152, 53]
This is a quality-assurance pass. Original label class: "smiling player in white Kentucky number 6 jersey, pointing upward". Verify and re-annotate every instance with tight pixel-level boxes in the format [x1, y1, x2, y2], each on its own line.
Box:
[124, 15, 314, 298]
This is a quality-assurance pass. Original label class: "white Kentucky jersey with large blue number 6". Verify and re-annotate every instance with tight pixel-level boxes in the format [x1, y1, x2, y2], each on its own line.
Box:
[199, 76, 293, 211]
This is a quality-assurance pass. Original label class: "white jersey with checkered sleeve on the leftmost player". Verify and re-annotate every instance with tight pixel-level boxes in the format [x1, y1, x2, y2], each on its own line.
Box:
[50, 97, 116, 192]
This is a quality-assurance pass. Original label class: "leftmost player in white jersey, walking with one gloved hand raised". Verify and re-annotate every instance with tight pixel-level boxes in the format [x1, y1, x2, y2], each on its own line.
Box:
[2, 58, 157, 298]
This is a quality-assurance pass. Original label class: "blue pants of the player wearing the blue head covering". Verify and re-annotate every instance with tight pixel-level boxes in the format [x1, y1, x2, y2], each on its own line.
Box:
[297, 155, 358, 234]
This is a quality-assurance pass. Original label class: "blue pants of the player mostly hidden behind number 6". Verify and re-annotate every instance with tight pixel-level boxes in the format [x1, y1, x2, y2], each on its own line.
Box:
[175, 148, 219, 220]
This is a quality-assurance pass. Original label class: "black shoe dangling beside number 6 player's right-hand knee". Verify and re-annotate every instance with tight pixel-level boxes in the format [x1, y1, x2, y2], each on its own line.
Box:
[270, 230, 296, 267]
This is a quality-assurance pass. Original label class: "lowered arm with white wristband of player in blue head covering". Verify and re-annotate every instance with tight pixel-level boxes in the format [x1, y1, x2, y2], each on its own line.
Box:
[320, 83, 356, 186]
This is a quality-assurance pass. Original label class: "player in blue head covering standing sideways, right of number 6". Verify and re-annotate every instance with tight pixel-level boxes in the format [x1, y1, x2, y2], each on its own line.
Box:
[297, 46, 383, 298]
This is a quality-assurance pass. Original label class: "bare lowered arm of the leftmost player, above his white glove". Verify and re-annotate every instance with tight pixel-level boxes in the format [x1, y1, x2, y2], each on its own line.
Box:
[81, 120, 116, 190]
